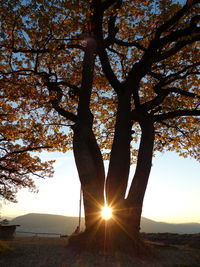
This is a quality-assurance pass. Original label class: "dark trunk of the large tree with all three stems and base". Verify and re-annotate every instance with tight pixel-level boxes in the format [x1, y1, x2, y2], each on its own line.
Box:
[70, 37, 154, 255]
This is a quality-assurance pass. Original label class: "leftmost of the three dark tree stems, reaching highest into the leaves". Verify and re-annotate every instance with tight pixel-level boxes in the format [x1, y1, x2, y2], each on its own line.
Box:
[73, 38, 105, 230]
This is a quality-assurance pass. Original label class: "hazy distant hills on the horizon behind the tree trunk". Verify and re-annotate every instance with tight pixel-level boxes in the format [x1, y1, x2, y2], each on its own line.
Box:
[11, 213, 200, 235]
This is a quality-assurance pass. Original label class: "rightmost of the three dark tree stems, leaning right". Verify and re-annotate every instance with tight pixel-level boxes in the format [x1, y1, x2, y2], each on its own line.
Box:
[126, 113, 154, 233]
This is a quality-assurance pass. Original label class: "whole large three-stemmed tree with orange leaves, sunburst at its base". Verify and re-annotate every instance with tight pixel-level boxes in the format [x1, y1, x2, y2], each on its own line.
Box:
[0, 0, 200, 253]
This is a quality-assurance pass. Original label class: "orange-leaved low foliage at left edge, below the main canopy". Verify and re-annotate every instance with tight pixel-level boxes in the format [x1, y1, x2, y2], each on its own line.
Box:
[0, 94, 53, 202]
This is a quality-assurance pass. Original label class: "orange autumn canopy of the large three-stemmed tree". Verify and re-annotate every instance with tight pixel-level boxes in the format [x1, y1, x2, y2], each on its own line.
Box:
[1, 0, 199, 161]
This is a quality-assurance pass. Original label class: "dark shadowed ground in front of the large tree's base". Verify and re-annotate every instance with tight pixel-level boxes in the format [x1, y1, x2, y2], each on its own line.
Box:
[0, 236, 200, 267]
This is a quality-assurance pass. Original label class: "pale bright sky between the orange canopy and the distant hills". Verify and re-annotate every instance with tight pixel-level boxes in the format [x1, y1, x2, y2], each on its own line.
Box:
[0, 152, 200, 223]
